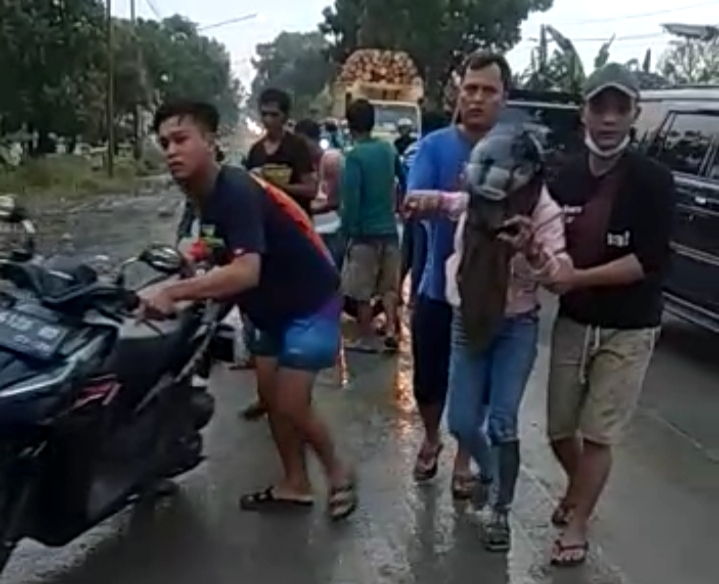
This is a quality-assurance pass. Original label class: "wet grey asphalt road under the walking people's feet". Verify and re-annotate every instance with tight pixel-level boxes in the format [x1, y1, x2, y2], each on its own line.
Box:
[1, 195, 719, 584]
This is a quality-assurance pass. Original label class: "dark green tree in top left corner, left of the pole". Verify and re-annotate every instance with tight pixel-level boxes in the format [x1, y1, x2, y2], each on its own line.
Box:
[0, 0, 104, 153]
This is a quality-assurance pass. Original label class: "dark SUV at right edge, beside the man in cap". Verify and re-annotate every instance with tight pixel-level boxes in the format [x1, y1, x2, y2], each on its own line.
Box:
[635, 87, 719, 332]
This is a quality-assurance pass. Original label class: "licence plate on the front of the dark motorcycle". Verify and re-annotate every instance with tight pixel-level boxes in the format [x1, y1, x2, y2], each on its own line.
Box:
[0, 309, 68, 359]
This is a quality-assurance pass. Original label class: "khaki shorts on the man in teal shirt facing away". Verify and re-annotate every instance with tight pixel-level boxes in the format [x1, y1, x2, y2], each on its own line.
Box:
[342, 242, 401, 302]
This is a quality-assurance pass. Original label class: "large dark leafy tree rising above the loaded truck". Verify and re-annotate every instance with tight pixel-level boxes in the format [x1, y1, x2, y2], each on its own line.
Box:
[320, 0, 552, 104]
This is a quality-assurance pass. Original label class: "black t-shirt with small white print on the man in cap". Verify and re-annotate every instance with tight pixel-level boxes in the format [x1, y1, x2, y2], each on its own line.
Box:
[548, 151, 675, 329]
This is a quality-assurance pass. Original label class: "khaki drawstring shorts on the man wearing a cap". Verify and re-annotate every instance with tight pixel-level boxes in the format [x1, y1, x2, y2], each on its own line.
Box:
[547, 317, 659, 445]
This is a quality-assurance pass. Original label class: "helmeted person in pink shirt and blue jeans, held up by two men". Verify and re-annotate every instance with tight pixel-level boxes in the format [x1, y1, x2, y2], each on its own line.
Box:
[405, 131, 571, 551]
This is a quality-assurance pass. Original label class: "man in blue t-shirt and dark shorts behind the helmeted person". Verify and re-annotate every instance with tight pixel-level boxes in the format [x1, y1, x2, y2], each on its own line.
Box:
[407, 53, 511, 499]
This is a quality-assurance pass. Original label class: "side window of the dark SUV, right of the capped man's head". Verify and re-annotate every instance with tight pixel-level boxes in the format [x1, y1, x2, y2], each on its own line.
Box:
[657, 112, 719, 175]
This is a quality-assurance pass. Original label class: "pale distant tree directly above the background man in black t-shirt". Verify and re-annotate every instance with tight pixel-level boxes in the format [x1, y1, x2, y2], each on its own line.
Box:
[251, 32, 334, 115]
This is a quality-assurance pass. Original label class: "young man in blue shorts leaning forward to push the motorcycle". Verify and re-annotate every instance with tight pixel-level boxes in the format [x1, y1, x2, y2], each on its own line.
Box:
[141, 102, 357, 519]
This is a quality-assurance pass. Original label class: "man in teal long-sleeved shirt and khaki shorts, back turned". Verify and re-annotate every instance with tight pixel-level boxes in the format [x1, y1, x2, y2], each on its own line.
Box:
[340, 99, 403, 353]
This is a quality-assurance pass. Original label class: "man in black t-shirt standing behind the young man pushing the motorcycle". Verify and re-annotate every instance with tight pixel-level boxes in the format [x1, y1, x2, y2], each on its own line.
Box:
[247, 89, 317, 215]
